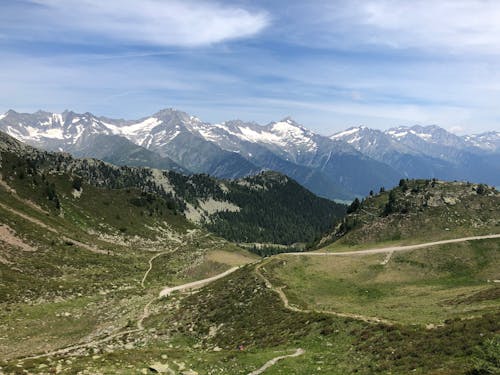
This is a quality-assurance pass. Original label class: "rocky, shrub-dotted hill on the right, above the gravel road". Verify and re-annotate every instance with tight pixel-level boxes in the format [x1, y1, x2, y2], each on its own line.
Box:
[318, 180, 500, 251]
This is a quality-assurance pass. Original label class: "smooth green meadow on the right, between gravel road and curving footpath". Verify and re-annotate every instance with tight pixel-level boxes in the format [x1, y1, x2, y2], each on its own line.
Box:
[266, 239, 500, 325]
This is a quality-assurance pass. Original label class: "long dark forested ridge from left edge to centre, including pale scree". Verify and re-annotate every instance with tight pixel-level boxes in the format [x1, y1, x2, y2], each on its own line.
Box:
[0, 133, 345, 244]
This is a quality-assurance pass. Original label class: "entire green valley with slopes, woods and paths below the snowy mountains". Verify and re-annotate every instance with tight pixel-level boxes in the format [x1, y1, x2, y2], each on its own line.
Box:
[0, 131, 500, 375]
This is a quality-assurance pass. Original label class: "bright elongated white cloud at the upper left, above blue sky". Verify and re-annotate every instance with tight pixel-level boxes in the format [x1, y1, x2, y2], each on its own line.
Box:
[27, 0, 270, 47]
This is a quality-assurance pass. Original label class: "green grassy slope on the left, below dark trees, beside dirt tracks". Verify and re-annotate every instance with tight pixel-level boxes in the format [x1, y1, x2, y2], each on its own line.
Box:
[0, 164, 254, 359]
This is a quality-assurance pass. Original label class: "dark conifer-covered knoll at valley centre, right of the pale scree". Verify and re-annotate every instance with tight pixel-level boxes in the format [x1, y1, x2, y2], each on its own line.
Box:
[207, 172, 345, 245]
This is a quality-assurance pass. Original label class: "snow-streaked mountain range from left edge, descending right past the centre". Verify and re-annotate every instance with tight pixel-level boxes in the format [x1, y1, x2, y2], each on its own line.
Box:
[0, 109, 400, 199]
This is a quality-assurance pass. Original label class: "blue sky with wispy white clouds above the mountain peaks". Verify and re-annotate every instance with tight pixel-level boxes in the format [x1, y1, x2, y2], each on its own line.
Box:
[0, 0, 500, 135]
